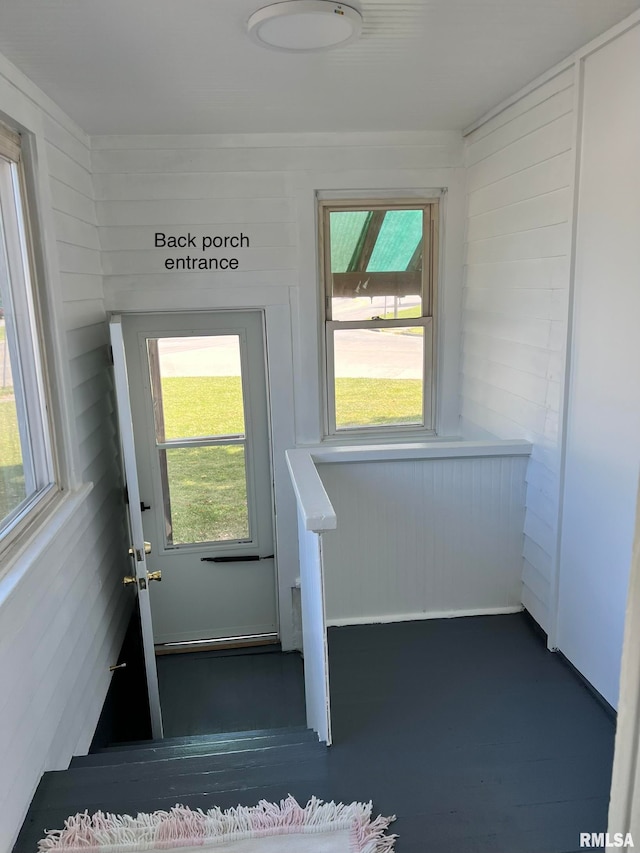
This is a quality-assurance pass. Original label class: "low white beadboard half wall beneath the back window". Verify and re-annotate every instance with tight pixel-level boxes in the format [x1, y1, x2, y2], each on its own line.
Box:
[318, 456, 527, 625]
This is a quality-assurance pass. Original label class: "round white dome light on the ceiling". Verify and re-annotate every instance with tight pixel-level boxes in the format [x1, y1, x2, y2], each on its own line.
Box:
[247, 0, 362, 51]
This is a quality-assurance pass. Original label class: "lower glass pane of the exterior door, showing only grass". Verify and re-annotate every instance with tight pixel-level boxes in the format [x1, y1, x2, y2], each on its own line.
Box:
[159, 445, 249, 545]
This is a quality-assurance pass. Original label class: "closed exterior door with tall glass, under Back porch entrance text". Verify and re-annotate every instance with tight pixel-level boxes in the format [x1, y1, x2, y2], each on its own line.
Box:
[122, 311, 278, 645]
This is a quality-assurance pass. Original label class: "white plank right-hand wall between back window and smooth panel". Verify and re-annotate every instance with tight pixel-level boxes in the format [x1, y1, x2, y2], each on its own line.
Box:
[461, 67, 575, 630]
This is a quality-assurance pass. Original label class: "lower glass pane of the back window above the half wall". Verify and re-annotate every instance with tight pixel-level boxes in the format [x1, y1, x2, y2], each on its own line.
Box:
[333, 326, 424, 429]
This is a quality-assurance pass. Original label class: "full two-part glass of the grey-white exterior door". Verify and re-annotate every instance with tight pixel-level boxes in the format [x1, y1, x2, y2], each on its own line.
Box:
[147, 335, 250, 546]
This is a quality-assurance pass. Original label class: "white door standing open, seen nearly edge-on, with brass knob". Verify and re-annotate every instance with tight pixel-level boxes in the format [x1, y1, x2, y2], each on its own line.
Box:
[109, 317, 162, 738]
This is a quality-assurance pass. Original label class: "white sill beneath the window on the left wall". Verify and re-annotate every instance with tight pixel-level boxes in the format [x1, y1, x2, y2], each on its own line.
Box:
[0, 483, 93, 606]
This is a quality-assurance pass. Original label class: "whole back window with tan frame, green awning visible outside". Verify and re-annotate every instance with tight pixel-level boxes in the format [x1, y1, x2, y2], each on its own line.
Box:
[320, 200, 438, 435]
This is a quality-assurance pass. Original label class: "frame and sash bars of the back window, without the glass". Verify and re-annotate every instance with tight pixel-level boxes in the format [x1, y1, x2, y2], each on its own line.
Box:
[318, 194, 440, 441]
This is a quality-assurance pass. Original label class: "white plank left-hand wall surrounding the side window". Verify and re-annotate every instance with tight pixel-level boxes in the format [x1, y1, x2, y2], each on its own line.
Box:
[0, 57, 129, 850]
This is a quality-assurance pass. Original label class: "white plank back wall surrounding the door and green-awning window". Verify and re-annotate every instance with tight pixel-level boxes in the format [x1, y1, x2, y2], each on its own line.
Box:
[92, 133, 463, 648]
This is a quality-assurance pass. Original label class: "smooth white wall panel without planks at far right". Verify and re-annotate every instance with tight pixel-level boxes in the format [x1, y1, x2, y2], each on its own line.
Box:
[557, 25, 640, 706]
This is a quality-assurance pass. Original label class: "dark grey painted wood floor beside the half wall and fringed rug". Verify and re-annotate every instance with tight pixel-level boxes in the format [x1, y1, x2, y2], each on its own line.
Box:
[17, 614, 614, 853]
